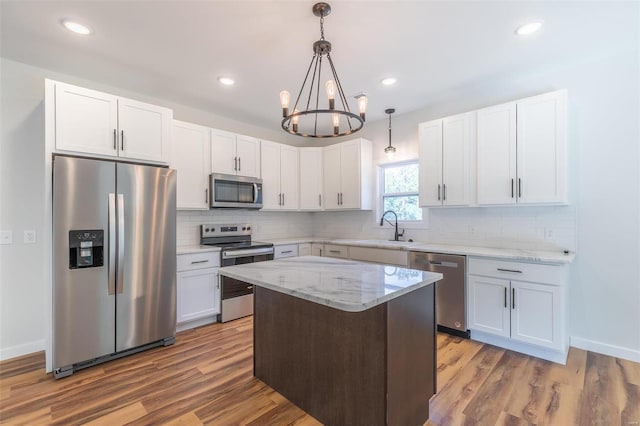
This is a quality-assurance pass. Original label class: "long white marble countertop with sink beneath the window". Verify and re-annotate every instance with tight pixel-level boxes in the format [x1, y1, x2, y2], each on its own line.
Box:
[262, 237, 575, 264]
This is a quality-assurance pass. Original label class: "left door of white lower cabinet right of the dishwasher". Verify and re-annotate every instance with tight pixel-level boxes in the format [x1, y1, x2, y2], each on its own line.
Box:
[469, 275, 511, 337]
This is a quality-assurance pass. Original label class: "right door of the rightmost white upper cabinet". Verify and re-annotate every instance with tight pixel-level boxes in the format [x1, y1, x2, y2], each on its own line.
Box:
[517, 90, 567, 203]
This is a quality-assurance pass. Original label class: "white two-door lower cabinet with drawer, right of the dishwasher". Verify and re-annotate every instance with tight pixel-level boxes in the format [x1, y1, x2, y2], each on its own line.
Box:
[468, 258, 568, 363]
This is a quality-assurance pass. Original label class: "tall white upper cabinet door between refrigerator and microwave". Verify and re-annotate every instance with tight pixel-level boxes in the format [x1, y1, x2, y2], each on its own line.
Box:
[169, 120, 211, 210]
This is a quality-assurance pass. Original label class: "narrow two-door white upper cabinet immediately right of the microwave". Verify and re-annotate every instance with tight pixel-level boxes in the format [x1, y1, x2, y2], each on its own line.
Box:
[260, 140, 299, 210]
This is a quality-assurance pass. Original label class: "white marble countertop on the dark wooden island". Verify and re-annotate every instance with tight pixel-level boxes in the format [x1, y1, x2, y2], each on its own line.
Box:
[218, 256, 442, 312]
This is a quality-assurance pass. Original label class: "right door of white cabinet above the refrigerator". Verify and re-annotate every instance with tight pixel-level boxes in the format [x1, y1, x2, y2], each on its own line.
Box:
[118, 98, 172, 163]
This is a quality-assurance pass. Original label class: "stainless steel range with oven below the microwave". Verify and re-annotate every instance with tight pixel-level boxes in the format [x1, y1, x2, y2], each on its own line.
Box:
[200, 223, 273, 322]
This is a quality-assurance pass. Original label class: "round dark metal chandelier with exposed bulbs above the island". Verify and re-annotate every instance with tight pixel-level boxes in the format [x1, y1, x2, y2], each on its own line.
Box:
[280, 3, 368, 138]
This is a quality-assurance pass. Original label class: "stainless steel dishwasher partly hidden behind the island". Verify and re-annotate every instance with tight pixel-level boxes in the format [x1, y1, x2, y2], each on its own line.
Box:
[409, 251, 469, 338]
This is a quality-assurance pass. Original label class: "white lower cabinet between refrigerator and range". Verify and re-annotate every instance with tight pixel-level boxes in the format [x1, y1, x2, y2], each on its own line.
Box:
[176, 252, 220, 331]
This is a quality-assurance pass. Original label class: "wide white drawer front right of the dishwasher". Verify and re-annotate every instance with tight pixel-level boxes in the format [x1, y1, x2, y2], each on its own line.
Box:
[468, 257, 567, 286]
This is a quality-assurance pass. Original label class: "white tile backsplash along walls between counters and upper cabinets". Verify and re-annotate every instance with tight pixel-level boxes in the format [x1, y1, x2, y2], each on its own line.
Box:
[177, 206, 577, 251]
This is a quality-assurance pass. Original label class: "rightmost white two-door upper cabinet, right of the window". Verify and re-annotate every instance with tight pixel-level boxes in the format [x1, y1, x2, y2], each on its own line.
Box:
[478, 90, 567, 204]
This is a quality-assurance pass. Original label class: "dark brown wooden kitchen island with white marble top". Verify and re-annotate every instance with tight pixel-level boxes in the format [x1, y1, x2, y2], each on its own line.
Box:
[219, 256, 442, 425]
